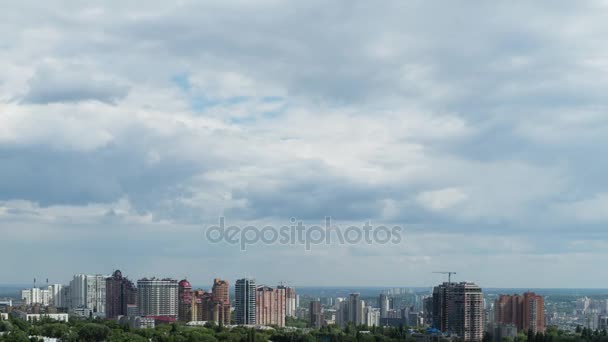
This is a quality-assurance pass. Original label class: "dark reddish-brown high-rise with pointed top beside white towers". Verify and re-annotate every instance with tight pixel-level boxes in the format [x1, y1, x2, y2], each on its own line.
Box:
[106, 270, 137, 319]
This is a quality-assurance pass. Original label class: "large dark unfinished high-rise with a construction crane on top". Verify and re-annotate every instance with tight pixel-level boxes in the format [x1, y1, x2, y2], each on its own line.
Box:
[433, 282, 483, 342]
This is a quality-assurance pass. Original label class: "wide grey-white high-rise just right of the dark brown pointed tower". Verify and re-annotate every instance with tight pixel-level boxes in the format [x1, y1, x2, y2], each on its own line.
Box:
[137, 278, 178, 318]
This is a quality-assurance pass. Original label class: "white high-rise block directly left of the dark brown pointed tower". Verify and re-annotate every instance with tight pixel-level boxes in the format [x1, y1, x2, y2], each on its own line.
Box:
[70, 274, 109, 316]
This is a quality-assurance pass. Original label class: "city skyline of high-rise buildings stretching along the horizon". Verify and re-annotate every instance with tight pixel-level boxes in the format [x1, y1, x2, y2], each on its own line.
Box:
[0, 270, 608, 342]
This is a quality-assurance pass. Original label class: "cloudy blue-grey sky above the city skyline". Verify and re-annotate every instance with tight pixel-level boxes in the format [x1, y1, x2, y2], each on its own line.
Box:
[0, 0, 608, 288]
